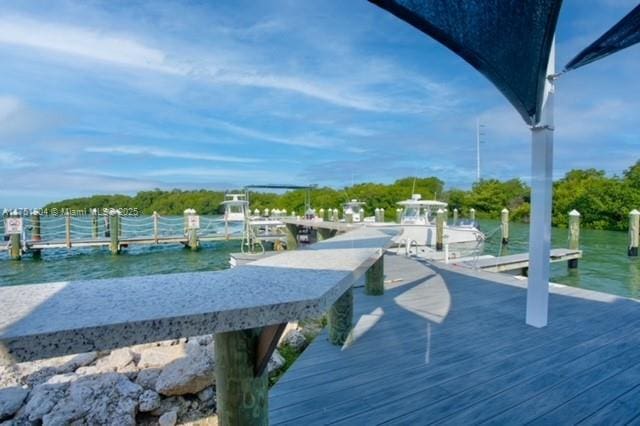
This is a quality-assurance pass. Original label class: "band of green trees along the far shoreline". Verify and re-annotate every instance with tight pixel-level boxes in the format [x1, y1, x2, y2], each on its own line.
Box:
[46, 161, 640, 230]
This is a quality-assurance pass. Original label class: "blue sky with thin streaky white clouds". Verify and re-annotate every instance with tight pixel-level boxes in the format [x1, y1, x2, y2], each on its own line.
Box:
[0, 0, 640, 207]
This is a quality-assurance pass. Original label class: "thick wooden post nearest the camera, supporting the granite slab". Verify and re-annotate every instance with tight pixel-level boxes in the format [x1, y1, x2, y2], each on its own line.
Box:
[214, 328, 269, 426]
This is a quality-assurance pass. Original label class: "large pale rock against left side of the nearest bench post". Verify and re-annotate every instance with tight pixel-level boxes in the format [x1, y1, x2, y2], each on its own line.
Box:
[156, 346, 215, 396]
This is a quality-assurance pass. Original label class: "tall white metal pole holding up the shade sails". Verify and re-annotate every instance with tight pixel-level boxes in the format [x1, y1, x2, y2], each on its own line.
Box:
[526, 40, 555, 327]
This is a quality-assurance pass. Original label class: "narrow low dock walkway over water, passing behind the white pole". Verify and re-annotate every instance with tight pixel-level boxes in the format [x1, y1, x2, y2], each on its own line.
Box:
[451, 248, 582, 272]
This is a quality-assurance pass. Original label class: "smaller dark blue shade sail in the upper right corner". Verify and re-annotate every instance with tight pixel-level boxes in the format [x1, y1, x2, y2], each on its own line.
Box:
[564, 4, 640, 71]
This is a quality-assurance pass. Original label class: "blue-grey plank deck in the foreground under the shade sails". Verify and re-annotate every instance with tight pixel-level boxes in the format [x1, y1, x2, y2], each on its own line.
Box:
[270, 255, 640, 426]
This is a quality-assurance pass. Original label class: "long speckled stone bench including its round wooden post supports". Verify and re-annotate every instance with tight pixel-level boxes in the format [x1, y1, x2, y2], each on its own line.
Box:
[0, 228, 396, 424]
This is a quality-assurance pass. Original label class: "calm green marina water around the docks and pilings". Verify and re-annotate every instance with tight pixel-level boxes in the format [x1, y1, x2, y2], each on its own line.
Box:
[0, 221, 640, 297]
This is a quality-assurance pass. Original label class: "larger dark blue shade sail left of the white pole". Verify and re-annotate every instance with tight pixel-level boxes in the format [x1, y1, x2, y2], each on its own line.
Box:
[369, 0, 562, 125]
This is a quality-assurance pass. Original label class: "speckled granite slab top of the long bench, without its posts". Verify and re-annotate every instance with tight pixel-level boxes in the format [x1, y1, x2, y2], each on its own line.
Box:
[0, 228, 397, 364]
